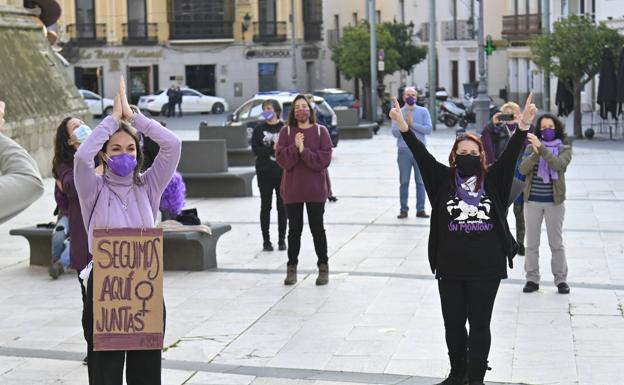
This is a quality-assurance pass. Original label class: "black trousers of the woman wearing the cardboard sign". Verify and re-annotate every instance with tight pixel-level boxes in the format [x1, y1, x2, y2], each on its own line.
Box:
[82, 271, 166, 385]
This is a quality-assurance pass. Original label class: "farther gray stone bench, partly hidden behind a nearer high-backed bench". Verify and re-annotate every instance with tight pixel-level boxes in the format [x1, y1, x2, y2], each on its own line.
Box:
[199, 122, 256, 167]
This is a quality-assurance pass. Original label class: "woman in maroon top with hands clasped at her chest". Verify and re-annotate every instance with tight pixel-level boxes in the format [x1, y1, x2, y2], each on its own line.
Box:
[275, 95, 332, 285]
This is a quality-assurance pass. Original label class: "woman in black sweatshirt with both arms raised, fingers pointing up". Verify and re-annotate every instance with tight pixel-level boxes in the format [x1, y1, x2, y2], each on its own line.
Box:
[390, 95, 537, 385]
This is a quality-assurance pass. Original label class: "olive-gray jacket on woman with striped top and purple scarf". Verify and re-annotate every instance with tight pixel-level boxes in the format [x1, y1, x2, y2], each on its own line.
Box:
[518, 144, 572, 205]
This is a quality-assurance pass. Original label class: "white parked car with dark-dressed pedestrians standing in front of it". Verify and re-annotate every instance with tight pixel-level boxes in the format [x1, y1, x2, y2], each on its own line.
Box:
[138, 87, 229, 115]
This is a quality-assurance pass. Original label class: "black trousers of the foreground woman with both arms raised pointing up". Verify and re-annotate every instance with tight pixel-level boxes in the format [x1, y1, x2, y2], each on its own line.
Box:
[438, 279, 500, 381]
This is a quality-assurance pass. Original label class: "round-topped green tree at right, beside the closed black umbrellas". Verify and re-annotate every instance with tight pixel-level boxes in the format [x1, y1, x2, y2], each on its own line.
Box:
[529, 15, 622, 138]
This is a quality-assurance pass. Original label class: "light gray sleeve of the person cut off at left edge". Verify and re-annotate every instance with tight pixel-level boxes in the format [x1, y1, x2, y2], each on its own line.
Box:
[0, 133, 43, 223]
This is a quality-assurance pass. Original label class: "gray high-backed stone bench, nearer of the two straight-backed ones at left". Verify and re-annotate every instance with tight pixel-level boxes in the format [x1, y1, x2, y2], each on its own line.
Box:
[178, 139, 256, 198]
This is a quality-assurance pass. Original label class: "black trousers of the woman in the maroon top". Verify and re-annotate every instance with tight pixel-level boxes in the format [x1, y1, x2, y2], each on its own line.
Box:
[286, 202, 328, 266]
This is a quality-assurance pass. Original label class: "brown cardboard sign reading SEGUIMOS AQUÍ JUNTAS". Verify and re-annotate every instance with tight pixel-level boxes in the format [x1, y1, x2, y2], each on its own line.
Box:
[93, 228, 163, 350]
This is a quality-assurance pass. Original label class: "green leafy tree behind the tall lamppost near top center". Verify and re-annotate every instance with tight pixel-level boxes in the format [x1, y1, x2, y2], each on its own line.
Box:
[332, 21, 423, 119]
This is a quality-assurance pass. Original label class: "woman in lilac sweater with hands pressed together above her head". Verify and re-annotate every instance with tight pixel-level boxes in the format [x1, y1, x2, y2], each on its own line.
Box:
[74, 78, 181, 385]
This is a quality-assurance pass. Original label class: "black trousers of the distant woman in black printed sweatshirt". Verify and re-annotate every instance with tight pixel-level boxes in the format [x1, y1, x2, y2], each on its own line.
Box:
[257, 172, 287, 242]
